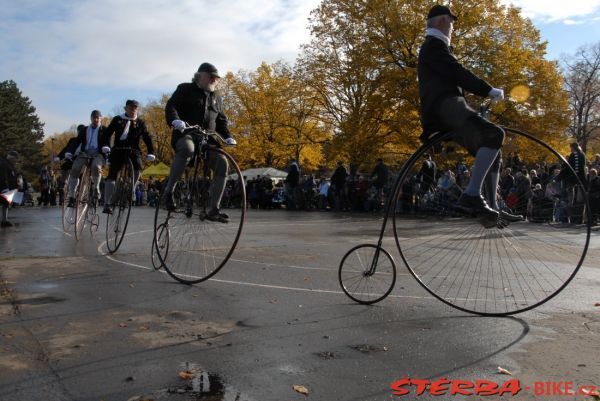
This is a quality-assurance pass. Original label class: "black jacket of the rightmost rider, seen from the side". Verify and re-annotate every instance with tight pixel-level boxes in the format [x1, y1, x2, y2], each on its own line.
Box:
[417, 36, 492, 139]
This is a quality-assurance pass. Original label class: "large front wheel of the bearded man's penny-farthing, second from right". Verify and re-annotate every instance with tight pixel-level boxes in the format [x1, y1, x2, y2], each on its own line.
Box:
[155, 149, 246, 284]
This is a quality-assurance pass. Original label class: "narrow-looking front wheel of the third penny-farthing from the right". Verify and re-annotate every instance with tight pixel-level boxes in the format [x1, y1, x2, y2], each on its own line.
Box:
[105, 158, 135, 254]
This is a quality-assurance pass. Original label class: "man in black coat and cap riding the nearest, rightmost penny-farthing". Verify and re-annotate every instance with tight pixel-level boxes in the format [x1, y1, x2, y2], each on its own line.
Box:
[417, 4, 522, 227]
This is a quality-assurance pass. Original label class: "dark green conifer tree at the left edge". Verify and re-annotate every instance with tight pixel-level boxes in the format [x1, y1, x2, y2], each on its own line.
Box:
[0, 80, 44, 174]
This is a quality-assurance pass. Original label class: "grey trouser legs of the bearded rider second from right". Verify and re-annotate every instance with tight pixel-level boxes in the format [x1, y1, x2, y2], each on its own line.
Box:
[165, 135, 229, 210]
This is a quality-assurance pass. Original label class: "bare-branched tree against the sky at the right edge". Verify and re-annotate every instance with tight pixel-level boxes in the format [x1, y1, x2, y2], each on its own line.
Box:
[564, 42, 600, 152]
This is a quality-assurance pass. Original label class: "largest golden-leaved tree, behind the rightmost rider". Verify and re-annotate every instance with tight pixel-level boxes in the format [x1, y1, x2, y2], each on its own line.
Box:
[298, 0, 567, 168]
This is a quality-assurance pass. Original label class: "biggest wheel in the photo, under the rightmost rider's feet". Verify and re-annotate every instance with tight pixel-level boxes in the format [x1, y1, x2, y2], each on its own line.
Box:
[393, 128, 591, 316]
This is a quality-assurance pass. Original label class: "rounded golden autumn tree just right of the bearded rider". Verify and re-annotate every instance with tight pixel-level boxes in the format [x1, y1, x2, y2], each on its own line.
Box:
[221, 62, 328, 171]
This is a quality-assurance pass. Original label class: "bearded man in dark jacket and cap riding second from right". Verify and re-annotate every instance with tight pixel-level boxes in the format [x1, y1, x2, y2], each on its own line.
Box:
[164, 63, 236, 223]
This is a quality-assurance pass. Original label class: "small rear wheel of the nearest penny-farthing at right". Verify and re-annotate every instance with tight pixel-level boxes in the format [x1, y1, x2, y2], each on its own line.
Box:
[338, 244, 396, 305]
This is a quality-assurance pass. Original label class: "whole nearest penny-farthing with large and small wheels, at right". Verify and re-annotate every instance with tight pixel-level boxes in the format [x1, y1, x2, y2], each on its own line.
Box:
[338, 103, 591, 316]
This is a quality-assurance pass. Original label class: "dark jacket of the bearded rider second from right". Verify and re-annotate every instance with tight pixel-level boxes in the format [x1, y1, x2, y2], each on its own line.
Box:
[165, 82, 231, 147]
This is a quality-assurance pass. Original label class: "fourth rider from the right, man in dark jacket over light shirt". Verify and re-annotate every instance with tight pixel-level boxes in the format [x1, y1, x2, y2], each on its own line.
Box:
[61, 110, 105, 207]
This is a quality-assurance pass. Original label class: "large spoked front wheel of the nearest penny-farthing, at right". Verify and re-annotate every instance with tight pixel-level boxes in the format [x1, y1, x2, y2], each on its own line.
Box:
[393, 128, 591, 316]
